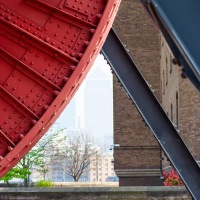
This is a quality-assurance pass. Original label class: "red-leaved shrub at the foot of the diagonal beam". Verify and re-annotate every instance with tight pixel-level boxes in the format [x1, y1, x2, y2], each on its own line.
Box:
[163, 170, 184, 186]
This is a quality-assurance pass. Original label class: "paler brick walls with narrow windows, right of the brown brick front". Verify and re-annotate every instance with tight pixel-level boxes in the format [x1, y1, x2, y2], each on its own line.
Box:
[161, 38, 200, 167]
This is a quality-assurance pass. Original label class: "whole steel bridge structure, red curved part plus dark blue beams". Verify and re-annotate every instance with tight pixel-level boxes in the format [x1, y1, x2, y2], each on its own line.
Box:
[0, 0, 200, 200]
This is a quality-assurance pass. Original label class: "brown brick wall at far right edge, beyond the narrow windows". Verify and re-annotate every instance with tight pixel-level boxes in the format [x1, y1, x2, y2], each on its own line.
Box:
[179, 78, 200, 161]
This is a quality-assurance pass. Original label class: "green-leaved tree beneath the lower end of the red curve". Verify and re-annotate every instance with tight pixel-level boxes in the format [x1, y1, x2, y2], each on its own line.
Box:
[0, 129, 64, 187]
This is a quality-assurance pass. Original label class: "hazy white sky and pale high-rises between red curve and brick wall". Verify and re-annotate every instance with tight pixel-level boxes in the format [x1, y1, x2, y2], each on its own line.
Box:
[53, 55, 113, 152]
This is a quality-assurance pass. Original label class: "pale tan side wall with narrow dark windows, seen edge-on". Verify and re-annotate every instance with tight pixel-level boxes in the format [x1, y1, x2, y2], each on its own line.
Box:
[160, 37, 181, 171]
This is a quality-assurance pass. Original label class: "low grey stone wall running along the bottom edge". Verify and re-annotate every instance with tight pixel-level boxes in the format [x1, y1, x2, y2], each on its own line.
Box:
[0, 187, 191, 200]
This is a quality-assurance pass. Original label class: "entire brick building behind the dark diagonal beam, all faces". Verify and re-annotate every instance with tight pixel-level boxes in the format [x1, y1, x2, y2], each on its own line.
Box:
[114, 0, 200, 186]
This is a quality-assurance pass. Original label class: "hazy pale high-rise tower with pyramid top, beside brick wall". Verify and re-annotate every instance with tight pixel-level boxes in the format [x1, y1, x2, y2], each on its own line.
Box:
[84, 67, 113, 150]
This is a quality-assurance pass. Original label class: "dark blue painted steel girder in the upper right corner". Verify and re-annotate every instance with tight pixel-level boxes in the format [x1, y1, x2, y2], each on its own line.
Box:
[141, 0, 200, 90]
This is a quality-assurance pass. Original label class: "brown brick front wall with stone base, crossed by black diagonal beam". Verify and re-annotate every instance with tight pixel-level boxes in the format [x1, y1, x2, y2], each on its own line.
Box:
[114, 0, 162, 186]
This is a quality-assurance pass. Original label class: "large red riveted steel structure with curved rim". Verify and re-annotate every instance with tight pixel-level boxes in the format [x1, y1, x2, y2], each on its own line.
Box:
[0, 0, 120, 177]
